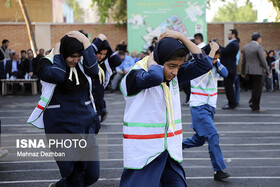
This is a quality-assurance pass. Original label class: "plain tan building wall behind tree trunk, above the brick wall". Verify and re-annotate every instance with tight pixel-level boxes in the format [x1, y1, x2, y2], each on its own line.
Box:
[0, 0, 53, 22]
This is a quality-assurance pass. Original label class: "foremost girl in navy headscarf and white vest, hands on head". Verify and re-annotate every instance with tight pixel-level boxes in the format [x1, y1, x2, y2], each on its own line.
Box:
[120, 30, 217, 187]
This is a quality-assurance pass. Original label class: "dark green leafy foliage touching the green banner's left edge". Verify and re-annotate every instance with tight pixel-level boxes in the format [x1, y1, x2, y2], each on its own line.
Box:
[91, 0, 127, 24]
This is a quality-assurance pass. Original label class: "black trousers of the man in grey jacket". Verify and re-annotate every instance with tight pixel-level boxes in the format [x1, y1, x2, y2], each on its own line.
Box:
[249, 75, 263, 110]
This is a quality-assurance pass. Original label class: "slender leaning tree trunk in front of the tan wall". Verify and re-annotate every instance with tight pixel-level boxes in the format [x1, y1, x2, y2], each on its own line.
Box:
[5, 0, 38, 57]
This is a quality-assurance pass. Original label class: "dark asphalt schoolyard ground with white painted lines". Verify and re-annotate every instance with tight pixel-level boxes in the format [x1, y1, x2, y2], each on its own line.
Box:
[0, 91, 280, 187]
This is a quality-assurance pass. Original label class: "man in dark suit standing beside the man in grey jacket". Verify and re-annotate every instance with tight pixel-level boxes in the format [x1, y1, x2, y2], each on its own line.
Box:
[220, 29, 240, 109]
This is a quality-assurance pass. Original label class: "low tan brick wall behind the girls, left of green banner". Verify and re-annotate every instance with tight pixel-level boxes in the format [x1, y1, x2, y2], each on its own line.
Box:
[0, 23, 127, 52]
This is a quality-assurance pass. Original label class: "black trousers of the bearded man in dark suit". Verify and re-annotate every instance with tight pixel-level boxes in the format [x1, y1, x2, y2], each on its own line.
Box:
[224, 72, 236, 108]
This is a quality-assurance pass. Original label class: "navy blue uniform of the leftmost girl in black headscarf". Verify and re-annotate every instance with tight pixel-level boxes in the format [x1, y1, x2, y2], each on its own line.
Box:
[38, 46, 99, 187]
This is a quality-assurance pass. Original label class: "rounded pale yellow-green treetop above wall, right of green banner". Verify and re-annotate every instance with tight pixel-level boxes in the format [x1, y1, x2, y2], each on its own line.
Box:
[212, 0, 258, 22]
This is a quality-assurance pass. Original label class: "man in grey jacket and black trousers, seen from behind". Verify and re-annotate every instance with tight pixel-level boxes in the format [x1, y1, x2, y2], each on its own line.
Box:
[241, 32, 271, 112]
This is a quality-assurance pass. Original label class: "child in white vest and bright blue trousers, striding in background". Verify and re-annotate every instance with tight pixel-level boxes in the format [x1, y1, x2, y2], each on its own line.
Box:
[183, 42, 230, 180]
